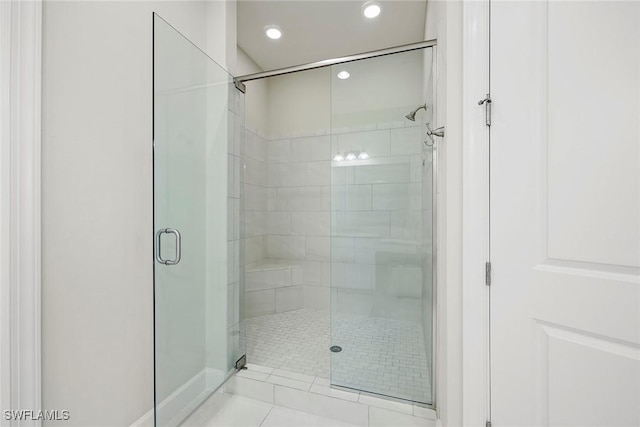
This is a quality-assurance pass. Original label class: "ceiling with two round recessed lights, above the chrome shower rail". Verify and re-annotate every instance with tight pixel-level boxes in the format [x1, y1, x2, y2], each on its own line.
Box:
[237, 0, 426, 70]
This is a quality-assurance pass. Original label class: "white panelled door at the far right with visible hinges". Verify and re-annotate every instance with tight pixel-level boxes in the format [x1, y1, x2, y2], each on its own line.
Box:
[490, 1, 640, 426]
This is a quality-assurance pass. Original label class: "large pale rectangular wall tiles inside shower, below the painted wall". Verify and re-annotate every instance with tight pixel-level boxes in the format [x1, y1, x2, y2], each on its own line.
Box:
[245, 122, 425, 317]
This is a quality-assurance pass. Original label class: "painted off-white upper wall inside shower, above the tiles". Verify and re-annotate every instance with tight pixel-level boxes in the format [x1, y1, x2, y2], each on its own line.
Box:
[262, 55, 424, 138]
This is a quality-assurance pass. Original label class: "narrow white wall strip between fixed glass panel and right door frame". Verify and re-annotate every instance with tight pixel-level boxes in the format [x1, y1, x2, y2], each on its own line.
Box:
[425, 1, 463, 426]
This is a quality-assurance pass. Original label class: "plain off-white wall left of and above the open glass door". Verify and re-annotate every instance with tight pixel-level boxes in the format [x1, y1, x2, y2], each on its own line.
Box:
[42, 1, 235, 426]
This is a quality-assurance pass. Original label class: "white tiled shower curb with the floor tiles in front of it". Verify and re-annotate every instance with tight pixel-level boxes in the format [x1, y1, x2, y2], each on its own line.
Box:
[175, 363, 436, 427]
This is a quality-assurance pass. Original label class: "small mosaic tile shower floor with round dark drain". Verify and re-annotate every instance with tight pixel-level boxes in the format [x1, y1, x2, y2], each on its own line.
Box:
[247, 309, 431, 403]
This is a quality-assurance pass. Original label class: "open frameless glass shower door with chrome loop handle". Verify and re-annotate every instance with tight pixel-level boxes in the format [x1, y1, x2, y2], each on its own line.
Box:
[153, 15, 244, 426]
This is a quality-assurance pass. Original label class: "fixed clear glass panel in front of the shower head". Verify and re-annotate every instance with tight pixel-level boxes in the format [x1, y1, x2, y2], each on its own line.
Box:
[331, 49, 434, 404]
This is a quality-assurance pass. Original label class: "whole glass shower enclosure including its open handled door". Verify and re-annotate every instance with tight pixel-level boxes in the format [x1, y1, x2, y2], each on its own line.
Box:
[153, 15, 438, 425]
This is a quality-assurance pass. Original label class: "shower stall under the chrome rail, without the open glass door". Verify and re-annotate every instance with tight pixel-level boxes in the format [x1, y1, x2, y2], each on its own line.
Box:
[236, 46, 443, 406]
